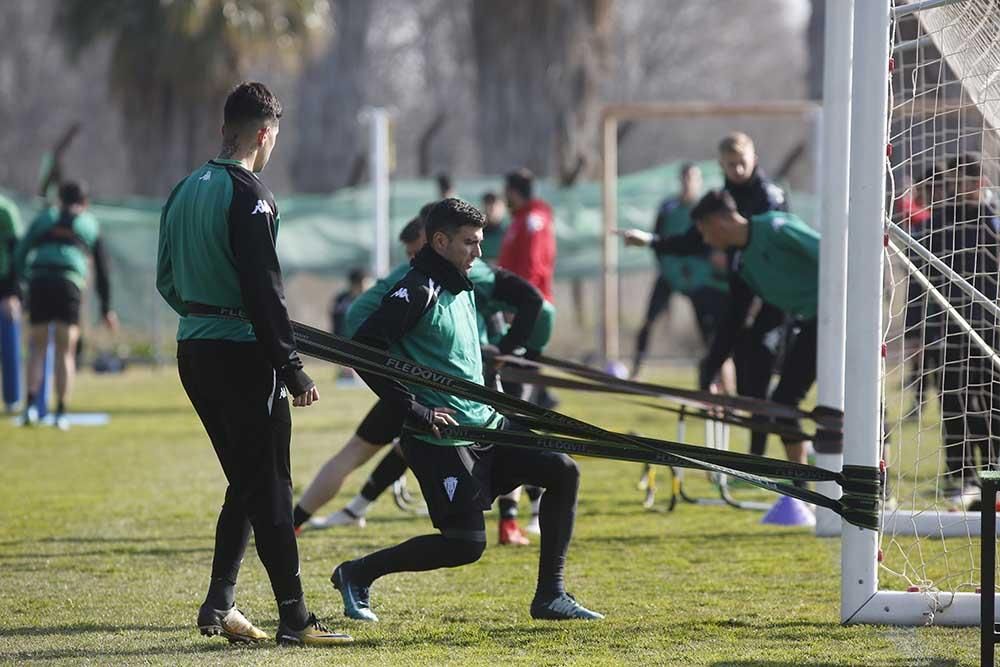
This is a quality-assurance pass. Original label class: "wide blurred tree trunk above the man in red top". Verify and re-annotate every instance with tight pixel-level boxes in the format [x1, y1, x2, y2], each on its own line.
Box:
[471, 0, 612, 184]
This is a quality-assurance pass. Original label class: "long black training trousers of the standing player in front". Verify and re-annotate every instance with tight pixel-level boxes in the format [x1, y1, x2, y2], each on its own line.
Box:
[177, 340, 305, 627]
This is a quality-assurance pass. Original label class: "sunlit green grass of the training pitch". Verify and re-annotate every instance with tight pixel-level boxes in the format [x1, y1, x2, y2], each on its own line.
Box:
[0, 362, 979, 667]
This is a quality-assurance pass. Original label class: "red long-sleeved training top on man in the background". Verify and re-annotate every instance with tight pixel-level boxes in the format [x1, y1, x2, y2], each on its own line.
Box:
[497, 199, 556, 301]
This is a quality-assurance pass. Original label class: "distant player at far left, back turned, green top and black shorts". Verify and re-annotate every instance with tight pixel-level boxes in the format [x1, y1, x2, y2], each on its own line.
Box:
[15, 181, 118, 431]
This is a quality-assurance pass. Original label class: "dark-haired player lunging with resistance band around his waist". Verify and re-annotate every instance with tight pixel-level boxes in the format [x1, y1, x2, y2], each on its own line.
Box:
[331, 199, 601, 621]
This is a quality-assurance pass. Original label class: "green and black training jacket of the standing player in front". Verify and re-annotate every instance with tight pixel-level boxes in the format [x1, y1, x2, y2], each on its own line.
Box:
[156, 159, 313, 396]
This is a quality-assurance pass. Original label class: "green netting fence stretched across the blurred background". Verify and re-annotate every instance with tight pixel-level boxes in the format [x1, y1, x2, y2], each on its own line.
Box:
[0, 162, 814, 358]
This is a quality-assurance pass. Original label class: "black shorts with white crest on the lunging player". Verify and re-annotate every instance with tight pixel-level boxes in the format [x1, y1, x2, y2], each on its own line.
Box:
[400, 420, 578, 531]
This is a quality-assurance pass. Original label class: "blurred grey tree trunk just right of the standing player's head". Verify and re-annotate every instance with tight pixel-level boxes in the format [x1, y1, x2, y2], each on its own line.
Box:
[292, 0, 372, 192]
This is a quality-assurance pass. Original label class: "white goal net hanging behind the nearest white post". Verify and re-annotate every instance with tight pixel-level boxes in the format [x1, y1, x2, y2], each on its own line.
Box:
[878, 0, 1000, 624]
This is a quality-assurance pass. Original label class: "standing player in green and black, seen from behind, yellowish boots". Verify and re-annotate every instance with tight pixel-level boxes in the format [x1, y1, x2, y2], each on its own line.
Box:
[156, 83, 352, 646]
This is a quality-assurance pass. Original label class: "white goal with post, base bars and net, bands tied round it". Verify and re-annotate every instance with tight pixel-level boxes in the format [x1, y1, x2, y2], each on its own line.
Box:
[841, 0, 1000, 626]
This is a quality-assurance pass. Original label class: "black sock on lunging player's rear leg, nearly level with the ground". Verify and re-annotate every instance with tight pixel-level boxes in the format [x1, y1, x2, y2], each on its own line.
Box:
[350, 535, 486, 585]
